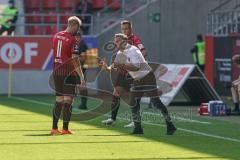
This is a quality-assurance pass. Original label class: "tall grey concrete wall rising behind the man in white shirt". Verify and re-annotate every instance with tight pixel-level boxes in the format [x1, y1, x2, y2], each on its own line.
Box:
[95, 0, 220, 90]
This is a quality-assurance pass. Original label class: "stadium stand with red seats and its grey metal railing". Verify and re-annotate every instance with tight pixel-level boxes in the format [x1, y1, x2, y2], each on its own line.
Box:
[0, 0, 152, 35]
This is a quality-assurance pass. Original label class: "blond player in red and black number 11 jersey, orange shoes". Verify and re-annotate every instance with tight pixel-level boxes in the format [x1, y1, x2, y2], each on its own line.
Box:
[51, 16, 85, 135]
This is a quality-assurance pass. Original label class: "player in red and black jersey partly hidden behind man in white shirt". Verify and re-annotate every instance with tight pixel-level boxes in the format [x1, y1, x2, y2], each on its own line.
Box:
[102, 20, 147, 127]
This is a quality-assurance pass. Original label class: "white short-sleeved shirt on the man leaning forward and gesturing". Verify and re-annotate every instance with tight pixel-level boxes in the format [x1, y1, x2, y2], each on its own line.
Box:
[114, 44, 152, 79]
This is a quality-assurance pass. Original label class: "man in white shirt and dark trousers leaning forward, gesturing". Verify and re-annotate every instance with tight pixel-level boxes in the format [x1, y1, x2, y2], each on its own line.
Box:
[103, 33, 176, 135]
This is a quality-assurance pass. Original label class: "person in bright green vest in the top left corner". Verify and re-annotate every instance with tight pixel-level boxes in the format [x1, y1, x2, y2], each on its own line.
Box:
[0, 0, 18, 35]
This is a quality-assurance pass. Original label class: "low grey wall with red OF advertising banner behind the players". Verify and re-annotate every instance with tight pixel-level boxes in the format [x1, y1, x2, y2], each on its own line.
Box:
[0, 36, 97, 94]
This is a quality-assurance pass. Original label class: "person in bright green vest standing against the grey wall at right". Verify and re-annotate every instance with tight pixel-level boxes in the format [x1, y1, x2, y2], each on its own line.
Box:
[191, 34, 205, 73]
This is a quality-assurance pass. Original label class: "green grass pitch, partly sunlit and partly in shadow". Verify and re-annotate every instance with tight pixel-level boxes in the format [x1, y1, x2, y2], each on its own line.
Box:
[0, 96, 240, 160]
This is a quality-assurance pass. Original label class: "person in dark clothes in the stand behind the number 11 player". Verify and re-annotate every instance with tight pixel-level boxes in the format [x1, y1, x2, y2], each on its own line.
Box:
[76, 0, 92, 35]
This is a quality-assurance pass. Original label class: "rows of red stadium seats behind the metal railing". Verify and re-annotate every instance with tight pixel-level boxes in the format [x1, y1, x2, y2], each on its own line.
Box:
[24, 0, 107, 35]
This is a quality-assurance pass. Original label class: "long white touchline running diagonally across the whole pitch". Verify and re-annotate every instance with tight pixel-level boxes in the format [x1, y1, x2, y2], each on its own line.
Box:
[11, 97, 240, 143]
